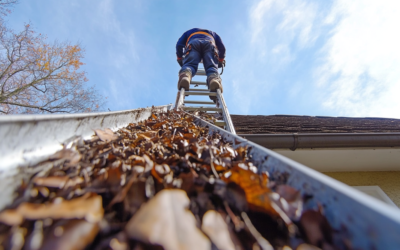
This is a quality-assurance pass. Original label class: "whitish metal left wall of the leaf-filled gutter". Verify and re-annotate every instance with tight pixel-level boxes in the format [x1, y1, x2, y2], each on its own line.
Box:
[0, 104, 172, 171]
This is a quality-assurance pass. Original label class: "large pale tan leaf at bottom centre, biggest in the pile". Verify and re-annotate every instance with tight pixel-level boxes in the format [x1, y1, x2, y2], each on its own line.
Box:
[126, 190, 211, 250]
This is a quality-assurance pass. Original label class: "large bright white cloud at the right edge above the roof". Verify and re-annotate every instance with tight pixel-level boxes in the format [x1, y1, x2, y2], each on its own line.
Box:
[315, 0, 400, 118]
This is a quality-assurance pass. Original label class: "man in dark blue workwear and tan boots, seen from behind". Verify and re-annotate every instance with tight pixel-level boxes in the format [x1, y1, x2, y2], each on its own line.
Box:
[176, 28, 225, 99]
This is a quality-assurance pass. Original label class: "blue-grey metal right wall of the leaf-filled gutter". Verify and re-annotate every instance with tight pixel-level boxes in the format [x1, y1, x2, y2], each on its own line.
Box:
[196, 118, 400, 250]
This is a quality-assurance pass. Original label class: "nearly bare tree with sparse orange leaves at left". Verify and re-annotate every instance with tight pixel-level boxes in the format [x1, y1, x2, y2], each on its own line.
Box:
[0, 22, 104, 114]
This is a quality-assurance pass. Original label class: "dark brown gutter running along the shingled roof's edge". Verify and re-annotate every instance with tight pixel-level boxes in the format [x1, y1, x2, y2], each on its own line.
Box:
[239, 133, 400, 150]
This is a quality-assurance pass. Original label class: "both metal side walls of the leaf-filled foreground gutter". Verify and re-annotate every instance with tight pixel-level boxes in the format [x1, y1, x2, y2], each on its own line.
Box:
[0, 109, 400, 250]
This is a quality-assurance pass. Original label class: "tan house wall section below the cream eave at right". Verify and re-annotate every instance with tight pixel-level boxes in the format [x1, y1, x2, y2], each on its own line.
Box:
[324, 171, 400, 207]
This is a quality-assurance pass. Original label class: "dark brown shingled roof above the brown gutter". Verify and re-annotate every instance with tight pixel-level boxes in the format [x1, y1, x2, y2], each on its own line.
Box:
[231, 115, 400, 134]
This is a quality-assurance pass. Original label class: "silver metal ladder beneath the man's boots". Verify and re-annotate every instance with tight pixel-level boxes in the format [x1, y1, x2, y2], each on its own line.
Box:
[175, 66, 236, 134]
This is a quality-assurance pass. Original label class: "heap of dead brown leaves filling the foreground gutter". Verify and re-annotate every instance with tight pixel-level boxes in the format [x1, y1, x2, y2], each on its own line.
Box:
[0, 111, 337, 250]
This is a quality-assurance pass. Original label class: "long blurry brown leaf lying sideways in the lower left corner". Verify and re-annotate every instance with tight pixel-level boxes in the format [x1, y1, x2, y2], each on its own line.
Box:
[0, 193, 104, 226]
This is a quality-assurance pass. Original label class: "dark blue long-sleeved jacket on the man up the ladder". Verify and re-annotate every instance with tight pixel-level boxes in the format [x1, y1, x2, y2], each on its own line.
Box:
[176, 28, 225, 62]
